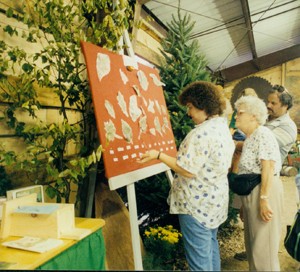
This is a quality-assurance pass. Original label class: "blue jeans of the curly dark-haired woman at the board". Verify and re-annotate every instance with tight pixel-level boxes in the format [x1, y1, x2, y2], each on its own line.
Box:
[178, 214, 221, 271]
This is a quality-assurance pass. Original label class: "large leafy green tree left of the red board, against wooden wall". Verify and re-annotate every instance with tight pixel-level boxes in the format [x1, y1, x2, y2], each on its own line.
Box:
[0, 0, 132, 208]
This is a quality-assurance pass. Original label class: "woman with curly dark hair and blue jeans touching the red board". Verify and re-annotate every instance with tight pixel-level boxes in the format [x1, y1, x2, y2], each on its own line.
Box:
[139, 81, 234, 271]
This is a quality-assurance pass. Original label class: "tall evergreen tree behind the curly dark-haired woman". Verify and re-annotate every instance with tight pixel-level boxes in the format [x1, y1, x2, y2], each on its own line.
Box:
[159, 10, 211, 146]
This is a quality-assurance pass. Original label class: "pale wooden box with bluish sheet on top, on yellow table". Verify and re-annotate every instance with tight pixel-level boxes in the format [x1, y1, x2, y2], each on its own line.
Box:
[0, 194, 90, 240]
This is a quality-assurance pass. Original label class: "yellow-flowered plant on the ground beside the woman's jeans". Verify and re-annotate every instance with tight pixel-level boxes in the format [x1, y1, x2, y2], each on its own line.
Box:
[143, 225, 186, 270]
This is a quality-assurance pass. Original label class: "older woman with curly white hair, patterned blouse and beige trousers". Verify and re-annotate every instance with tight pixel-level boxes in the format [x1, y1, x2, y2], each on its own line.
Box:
[235, 96, 283, 271]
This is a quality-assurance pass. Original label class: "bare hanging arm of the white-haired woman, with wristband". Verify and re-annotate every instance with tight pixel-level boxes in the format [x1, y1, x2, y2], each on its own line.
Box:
[259, 160, 275, 222]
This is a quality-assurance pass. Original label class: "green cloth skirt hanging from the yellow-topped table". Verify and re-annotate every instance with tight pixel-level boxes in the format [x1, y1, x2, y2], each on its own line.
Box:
[37, 229, 105, 271]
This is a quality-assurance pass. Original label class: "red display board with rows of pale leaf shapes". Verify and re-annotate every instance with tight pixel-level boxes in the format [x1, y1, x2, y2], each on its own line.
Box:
[81, 42, 176, 184]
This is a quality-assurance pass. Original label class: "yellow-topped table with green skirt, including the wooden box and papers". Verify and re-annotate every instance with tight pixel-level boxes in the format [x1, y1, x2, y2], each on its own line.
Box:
[0, 194, 106, 271]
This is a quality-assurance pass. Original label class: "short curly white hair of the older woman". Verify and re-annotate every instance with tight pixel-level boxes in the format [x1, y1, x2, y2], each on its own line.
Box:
[234, 96, 268, 125]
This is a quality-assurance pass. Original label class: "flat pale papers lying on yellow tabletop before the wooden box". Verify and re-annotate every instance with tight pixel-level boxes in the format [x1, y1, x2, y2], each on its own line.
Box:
[2, 236, 63, 253]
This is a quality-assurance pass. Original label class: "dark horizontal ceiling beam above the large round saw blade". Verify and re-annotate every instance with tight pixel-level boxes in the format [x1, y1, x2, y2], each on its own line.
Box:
[221, 44, 300, 82]
